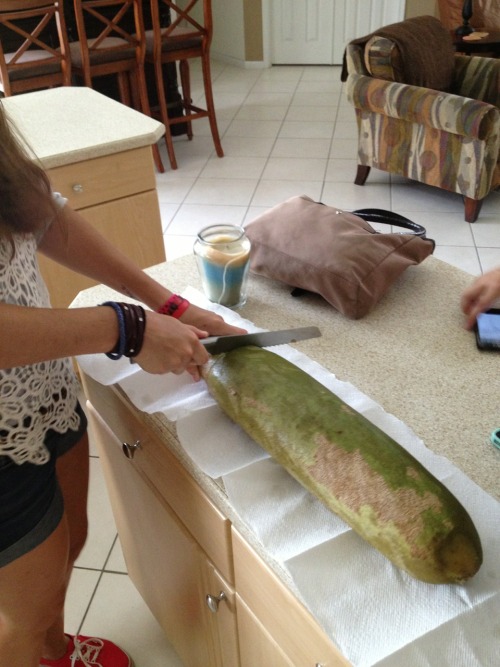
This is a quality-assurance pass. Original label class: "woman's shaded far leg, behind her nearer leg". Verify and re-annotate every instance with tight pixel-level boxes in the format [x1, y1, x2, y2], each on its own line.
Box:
[41, 434, 89, 664]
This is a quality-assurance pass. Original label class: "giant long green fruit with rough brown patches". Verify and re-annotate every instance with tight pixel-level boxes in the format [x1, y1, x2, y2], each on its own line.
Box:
[202, 346, 482, 583]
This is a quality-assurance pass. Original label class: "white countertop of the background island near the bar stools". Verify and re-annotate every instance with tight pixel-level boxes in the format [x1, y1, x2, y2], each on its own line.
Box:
[2, 86, 165, 169]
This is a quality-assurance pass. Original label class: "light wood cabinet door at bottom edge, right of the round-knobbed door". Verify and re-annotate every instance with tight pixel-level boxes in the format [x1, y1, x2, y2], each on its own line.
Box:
[236, 595, 294, 667]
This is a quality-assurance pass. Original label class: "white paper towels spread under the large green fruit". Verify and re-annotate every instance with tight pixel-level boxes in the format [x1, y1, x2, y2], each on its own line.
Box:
[79, 288, 500, 667]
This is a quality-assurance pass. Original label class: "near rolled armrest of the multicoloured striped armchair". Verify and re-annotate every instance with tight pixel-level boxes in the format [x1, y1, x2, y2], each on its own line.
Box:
[347, 74, 500, 139]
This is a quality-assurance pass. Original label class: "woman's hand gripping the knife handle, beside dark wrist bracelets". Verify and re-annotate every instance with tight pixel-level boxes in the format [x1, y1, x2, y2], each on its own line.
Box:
[134, 311, 209, 381]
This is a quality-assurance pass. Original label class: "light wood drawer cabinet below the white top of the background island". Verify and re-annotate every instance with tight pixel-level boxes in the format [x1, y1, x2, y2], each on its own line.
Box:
[39, 146, 165, 308]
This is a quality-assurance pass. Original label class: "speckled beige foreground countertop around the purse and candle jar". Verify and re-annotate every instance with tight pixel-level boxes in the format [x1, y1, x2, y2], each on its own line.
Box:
[72, 256, 500, 500]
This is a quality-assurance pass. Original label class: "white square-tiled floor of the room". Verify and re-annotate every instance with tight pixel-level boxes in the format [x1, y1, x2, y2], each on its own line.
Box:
[67, 63, 500, 667]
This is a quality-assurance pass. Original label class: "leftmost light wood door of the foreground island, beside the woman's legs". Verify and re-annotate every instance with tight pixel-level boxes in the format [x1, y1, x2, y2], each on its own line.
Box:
[87, 404, 211, 667]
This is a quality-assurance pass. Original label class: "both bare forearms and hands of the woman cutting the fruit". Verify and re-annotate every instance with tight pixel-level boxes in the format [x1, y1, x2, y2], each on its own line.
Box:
[0, 206, 244, 379]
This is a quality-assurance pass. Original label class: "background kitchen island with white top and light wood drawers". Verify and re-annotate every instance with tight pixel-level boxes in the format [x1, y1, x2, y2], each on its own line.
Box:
[2, 86, 165, 308]
